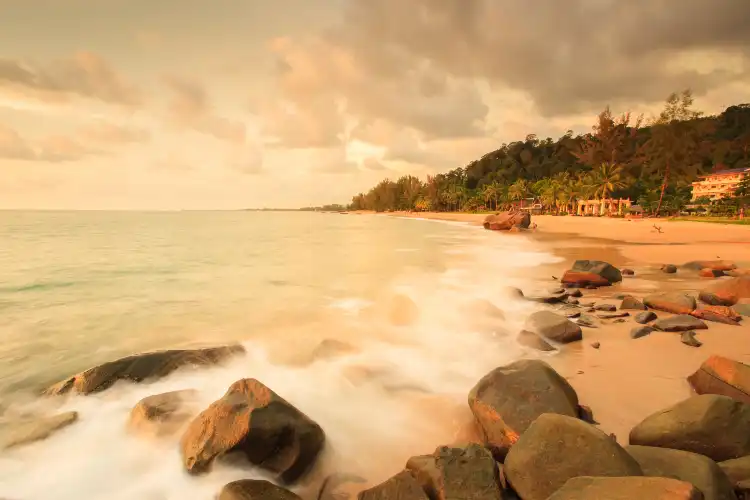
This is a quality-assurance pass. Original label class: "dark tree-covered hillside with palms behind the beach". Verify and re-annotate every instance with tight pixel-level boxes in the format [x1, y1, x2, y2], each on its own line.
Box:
[342, 90, 750, 214]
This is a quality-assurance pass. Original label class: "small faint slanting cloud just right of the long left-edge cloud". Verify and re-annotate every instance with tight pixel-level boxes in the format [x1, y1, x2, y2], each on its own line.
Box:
[164, 76, 246, 144]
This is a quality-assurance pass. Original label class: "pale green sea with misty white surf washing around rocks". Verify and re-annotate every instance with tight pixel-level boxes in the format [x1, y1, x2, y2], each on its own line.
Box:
[0, 212, 558, 500]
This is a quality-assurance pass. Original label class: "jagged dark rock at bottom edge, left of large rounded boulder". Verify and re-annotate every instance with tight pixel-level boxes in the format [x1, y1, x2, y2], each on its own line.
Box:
[406, 444, 501, 500]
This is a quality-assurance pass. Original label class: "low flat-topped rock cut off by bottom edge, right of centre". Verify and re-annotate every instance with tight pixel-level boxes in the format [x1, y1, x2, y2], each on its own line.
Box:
[547, 476, 704, 500]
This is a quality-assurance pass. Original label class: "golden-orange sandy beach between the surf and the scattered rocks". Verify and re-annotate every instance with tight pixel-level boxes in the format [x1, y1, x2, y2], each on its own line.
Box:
[378, 213, 750, 444]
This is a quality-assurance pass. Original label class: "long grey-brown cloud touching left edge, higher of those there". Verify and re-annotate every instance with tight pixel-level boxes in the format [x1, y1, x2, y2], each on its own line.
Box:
[0, 51, 143, 107]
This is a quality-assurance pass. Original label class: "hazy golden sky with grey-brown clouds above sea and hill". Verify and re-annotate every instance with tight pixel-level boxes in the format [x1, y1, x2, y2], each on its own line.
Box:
[0, 0, 750, 210]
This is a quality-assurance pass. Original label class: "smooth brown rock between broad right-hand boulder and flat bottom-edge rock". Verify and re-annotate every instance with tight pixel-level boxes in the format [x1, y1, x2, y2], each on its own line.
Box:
[625, 446, 737, 500]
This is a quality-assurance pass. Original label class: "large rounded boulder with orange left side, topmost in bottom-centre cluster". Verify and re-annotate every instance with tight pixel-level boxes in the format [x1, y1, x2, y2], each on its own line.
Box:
[469, 359, 578, 458]
